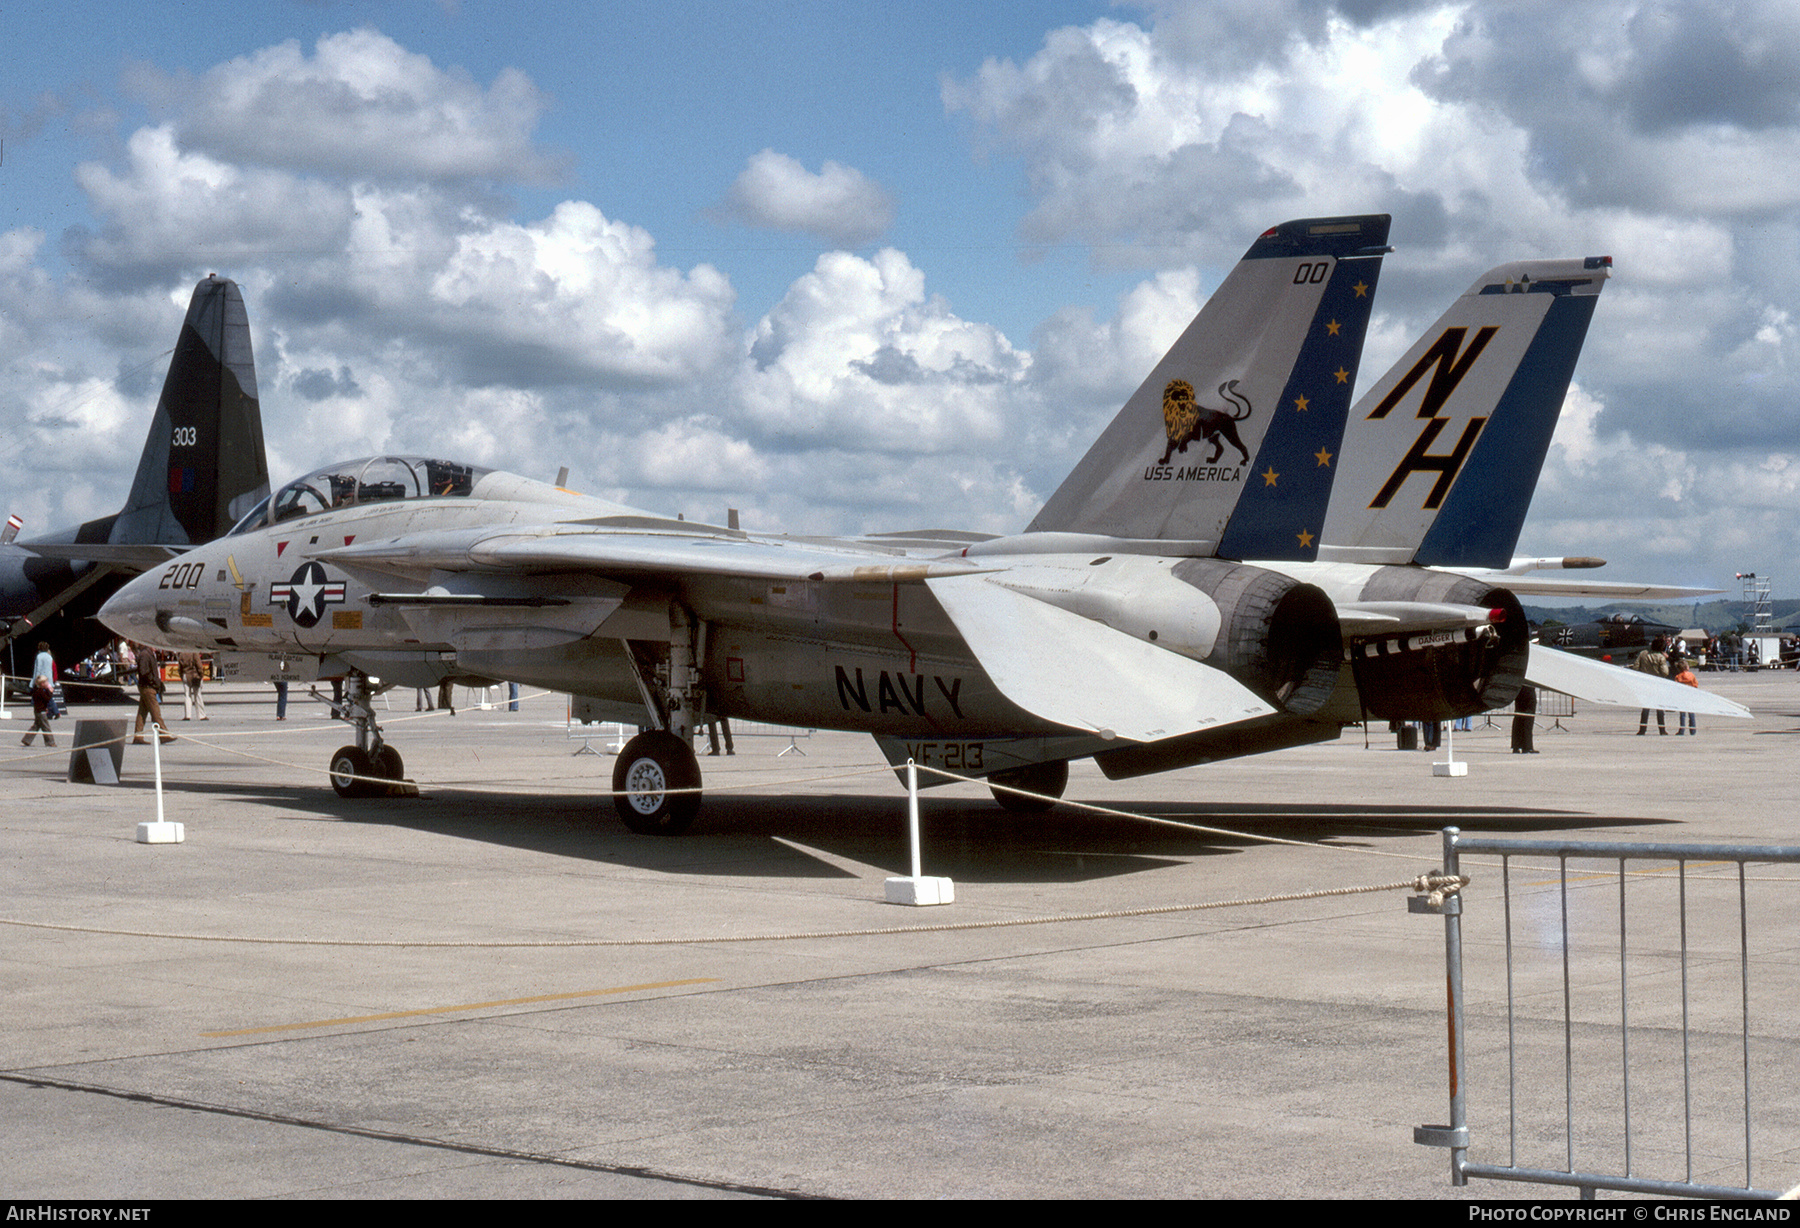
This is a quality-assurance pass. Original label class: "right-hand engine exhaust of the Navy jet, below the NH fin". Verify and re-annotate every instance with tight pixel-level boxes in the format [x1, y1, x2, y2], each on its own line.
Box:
[1348, 567, 1530, 720]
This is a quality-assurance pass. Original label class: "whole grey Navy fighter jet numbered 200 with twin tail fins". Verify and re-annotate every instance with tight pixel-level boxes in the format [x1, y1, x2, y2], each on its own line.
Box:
[103, 216, 1748, 835]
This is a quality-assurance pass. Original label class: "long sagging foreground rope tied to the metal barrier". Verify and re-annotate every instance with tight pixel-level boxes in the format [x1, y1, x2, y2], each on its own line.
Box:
[0, 875, 1469, 943]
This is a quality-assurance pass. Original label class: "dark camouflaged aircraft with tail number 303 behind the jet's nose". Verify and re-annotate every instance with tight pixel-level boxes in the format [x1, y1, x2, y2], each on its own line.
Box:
[0, 275, 268, 663]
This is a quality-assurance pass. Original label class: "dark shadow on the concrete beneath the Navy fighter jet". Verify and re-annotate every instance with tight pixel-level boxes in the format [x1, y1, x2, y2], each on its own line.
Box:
[94, 781, 1663, 882]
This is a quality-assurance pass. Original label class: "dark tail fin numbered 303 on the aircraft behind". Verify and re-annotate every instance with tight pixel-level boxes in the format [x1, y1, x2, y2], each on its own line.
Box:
[108, 275, 268, 546]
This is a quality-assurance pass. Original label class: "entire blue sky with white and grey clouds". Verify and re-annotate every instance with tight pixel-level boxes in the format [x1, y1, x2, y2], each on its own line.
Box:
[0, 0, 1800, 594]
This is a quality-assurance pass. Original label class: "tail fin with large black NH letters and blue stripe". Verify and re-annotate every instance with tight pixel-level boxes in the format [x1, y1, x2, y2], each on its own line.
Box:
[1319, 256, 1613, 567]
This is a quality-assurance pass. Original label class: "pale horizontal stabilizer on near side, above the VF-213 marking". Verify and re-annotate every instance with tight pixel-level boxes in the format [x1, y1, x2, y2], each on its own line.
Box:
[925, 576, 1274, 742]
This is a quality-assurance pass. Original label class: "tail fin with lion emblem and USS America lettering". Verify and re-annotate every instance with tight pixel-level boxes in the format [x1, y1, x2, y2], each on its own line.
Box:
[1026, 214, 1390, 558]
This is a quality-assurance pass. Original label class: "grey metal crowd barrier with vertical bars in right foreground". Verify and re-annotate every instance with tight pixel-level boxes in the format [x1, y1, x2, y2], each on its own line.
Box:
[1409, 828, 1800, 1199]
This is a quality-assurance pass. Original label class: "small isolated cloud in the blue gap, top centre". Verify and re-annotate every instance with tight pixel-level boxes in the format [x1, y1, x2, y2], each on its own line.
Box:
[722, 149, 895, 247]
